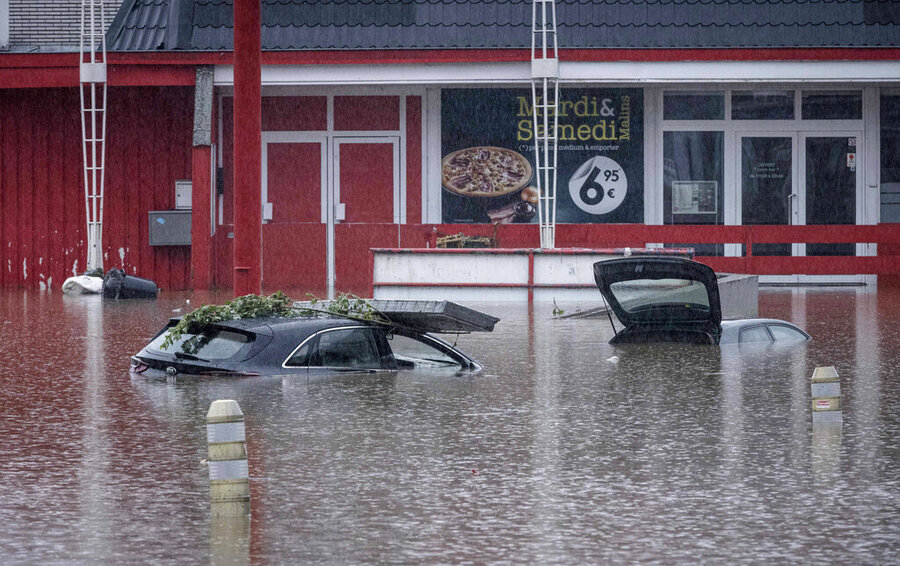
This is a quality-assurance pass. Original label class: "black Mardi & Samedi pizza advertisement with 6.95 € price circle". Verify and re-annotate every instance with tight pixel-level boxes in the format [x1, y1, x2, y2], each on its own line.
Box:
[441, 88, 644, 224]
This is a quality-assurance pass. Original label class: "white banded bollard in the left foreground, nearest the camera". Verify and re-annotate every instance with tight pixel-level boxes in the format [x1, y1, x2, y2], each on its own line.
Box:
[206, 399, 250, 517]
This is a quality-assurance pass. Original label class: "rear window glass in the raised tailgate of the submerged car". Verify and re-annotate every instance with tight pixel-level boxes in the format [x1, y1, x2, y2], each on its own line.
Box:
[609, 279, 709, 313]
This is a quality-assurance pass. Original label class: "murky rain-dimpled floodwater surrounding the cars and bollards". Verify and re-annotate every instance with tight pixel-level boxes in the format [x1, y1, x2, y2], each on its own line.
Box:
[0, 288, 900, 564]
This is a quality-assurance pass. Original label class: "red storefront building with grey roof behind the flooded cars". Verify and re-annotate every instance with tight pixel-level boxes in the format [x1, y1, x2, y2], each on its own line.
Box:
[0, 0, 900, 295]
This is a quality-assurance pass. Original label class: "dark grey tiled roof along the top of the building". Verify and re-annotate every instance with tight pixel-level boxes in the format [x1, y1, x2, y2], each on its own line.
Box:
[107, 0, 900, 51]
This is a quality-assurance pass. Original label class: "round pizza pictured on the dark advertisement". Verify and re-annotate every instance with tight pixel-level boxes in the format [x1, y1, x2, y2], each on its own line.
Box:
[441, 146, 534, 197]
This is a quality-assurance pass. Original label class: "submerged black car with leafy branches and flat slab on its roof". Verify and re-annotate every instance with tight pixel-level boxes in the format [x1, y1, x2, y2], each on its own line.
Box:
[131, 301, 499, 377]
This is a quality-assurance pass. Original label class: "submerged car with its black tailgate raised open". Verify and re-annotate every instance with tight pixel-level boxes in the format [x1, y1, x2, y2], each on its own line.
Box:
[594, 256, 810, 344]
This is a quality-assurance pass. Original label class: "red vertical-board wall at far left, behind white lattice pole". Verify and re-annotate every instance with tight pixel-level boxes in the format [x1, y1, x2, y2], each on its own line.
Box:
[0, 87, 193, 289]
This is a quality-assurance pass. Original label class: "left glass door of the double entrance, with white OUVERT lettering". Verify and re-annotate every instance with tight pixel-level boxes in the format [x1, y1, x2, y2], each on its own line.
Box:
[736, 133, 801, 283]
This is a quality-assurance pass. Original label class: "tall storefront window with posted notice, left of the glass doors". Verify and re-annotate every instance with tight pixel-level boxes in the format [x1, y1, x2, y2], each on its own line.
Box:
[663, 132, 725, 256]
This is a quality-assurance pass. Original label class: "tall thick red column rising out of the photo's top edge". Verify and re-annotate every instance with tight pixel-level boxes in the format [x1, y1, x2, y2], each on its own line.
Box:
[234, 0, 262, 297]
